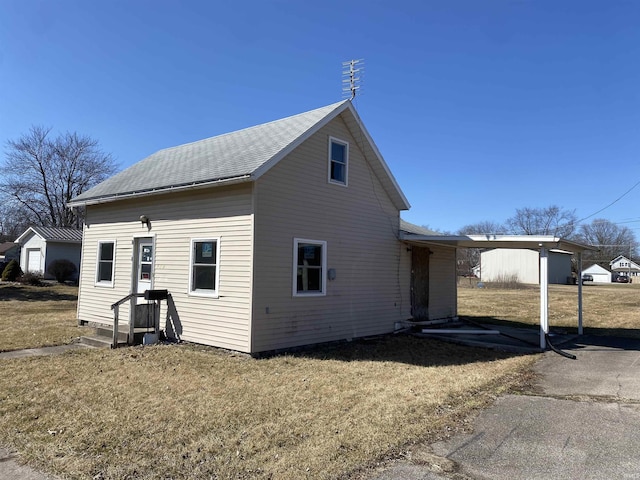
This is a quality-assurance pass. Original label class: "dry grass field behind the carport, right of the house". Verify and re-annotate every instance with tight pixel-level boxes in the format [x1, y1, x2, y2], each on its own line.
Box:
[458, 279, 640, 338]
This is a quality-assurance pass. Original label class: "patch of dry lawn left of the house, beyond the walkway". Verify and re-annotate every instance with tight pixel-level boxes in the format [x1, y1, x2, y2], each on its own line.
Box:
[0, 282, 82, 352]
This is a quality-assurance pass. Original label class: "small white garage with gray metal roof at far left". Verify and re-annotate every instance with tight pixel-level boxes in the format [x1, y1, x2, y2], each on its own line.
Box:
[15, 227, 82, 280]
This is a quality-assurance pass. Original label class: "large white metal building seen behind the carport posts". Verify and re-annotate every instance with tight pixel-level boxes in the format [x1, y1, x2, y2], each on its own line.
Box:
[478, 248, 572, 285]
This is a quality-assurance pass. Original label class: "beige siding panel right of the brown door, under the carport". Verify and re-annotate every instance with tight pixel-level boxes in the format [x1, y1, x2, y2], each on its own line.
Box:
[429, 246, 458, 320]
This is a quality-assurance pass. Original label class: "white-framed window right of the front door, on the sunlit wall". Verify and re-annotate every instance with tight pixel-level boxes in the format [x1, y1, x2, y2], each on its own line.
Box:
[189, 238, 220, 297]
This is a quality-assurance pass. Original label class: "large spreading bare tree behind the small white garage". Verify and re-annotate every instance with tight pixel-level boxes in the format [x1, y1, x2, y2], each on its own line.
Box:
[0, 126, 116, 227]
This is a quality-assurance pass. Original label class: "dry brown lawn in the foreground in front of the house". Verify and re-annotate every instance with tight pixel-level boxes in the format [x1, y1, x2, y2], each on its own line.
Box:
[0, 284, 537, 479]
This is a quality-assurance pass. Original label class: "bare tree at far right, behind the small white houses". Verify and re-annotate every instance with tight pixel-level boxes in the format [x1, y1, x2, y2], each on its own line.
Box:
[576, 218, 638, 269]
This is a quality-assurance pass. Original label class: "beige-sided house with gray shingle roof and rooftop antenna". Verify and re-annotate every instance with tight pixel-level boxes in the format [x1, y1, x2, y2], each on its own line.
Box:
[69, 101, 457, 354]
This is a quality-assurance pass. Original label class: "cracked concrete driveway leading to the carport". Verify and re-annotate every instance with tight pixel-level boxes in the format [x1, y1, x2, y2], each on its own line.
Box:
[373, 336, 640, 480]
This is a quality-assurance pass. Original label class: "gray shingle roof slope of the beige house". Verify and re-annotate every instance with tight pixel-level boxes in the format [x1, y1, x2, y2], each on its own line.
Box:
[69, 100, 350, 206]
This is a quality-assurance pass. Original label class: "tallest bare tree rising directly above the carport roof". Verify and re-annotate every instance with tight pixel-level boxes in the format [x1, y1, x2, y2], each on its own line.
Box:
[506, 205, 578, 238]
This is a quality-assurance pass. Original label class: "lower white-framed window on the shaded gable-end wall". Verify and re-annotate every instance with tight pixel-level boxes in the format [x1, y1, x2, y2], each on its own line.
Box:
[293, 238, 327, 297]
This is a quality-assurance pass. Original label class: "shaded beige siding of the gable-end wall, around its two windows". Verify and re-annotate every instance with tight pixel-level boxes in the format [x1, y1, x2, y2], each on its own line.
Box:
[252, 113, 409, 352]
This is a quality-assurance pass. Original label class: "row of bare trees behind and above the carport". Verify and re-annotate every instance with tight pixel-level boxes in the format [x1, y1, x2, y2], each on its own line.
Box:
[457, 205, 638, 274]
